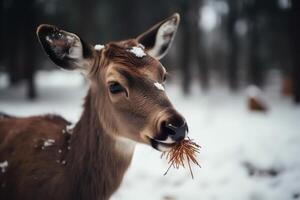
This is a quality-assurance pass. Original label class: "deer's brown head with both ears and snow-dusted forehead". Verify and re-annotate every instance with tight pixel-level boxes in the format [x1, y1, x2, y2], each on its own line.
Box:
[37, 14, 187, 151]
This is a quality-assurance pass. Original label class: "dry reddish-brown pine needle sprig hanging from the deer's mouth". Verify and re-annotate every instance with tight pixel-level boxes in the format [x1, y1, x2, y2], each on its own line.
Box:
[161, 137, 201, 178]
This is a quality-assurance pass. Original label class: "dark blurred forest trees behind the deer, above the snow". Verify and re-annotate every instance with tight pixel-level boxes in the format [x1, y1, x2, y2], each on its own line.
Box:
[0, 0, 300, 103]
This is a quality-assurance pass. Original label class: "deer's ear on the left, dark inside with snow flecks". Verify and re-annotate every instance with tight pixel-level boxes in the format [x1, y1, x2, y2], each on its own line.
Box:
[37, 24, 93, 70]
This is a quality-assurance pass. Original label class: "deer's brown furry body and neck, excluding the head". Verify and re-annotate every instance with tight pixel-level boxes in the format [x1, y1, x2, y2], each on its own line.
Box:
[0, 93, 130, 200]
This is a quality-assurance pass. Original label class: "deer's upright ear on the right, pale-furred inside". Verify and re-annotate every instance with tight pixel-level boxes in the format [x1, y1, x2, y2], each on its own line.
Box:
[137, 13, 180, 59]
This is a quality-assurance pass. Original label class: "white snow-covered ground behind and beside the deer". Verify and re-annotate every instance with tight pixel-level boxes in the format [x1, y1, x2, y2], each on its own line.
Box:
[0, 71, 300, 200]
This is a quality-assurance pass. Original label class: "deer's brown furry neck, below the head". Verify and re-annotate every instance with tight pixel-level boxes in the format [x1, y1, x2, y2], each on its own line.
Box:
[67, 91, 134, 199]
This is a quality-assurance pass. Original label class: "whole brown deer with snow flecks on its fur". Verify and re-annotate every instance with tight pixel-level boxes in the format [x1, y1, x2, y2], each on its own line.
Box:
[0, 13, 188, 200]
